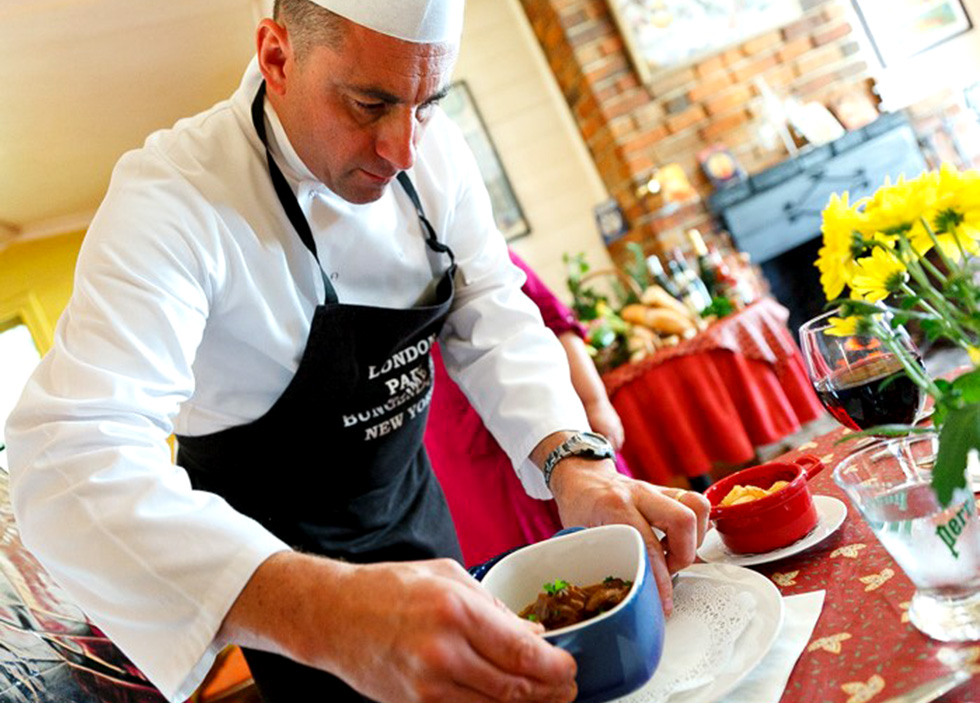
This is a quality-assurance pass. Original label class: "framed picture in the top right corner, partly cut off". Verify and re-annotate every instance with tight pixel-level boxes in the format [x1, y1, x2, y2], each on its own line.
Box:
[851, 0, 973, 66]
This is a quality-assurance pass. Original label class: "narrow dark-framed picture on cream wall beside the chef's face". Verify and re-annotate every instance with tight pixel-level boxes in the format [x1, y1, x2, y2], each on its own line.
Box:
[440, 81, 531, 241]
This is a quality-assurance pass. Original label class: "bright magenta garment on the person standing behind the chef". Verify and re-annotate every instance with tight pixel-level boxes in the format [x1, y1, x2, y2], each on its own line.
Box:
[425, 252, 628, 566]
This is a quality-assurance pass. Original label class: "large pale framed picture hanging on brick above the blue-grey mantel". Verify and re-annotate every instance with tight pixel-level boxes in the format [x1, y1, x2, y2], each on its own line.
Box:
[609, 0, 803, 83]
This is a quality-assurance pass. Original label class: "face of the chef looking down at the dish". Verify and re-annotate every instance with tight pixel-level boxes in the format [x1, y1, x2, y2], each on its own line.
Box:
[275, 25, 457, 203]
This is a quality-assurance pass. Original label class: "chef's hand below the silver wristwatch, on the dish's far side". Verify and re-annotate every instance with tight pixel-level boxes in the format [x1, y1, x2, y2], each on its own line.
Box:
[551, 456, 711, 614]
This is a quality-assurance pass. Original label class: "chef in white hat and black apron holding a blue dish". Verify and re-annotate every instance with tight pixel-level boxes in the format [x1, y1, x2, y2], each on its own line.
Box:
[7, 0, 707, 703]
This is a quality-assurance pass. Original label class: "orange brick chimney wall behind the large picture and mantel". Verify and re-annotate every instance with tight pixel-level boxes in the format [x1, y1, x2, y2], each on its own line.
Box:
[521, 0, 868, 259]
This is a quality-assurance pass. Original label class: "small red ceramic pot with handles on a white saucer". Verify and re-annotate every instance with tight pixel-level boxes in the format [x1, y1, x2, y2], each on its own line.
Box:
[704, 454, 824, 554]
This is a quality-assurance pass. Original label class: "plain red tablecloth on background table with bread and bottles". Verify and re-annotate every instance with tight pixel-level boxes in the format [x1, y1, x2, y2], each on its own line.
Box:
[603, 298, 824, 485]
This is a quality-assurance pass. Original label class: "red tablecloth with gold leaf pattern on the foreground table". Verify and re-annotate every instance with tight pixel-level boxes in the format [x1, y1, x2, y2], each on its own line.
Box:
[752, 428, 980, 703]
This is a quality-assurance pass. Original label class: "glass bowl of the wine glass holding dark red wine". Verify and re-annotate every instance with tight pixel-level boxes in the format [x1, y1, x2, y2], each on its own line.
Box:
[800, 310, 924, 438]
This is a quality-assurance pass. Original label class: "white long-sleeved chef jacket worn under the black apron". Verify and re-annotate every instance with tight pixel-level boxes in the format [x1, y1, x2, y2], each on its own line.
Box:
[6, 59, 587, 701]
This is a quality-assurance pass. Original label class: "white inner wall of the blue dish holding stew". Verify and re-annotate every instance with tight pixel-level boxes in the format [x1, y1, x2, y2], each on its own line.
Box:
[483, 525, 646, 634]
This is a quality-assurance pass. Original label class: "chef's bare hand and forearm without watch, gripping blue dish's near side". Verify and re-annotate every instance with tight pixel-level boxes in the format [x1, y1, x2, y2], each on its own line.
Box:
[222, 552, 577, 703]
